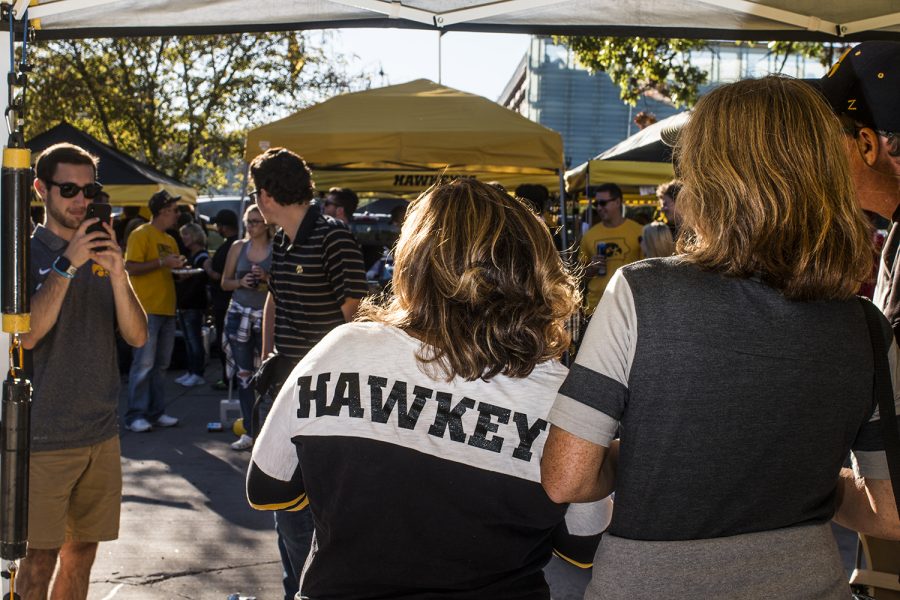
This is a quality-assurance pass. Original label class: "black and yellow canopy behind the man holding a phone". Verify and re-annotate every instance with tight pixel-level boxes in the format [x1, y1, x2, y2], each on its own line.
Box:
[25, 123, 197, 206]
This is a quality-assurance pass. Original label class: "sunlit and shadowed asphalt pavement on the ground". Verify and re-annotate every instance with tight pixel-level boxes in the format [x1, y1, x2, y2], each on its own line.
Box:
[82, 364, 855, 600]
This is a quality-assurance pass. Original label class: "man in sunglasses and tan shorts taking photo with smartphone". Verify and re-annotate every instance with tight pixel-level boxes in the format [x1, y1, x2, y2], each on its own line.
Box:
[17, 144, 147, 600]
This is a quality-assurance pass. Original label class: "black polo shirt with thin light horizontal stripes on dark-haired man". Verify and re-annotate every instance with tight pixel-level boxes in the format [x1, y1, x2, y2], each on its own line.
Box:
[269, 206, 367, 358]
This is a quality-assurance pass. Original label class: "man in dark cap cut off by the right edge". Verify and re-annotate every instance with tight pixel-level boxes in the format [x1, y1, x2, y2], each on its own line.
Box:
[818, 41, 900, 340]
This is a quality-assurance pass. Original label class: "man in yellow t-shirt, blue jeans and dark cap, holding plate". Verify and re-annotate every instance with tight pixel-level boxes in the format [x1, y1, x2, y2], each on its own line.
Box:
[125, 190, 185, 433]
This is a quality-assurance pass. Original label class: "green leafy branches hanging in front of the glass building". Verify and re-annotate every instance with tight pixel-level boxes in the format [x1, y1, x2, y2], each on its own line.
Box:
[553, 36, 708, 106]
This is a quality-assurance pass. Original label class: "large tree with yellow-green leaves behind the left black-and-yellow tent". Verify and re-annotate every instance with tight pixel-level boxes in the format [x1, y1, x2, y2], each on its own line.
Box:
[27, 32, 368, 190]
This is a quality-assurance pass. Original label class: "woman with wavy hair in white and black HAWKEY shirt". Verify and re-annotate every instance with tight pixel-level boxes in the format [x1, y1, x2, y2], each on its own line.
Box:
[247, 179, 592, 599]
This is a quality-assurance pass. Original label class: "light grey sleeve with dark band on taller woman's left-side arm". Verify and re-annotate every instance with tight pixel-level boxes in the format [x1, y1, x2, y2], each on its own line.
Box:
[549, 271, 637, 446]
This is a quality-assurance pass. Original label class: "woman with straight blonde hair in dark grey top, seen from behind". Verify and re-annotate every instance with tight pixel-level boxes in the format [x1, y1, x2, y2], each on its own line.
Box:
[542, 76, 900, 600]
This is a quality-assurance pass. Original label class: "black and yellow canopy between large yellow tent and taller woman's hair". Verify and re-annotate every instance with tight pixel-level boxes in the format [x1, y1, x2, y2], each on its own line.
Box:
[565, 111, 690, 192]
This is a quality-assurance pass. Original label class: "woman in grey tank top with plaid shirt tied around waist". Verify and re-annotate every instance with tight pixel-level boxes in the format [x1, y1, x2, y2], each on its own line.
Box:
[221, 204, 272, 450]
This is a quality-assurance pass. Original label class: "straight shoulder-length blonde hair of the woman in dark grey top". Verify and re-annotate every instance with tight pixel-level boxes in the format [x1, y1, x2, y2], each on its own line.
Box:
[675, 76, 872, 300]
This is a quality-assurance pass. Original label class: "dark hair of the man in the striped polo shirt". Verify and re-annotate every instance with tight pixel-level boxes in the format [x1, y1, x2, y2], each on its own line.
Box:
[250, 148, 316, 206]
